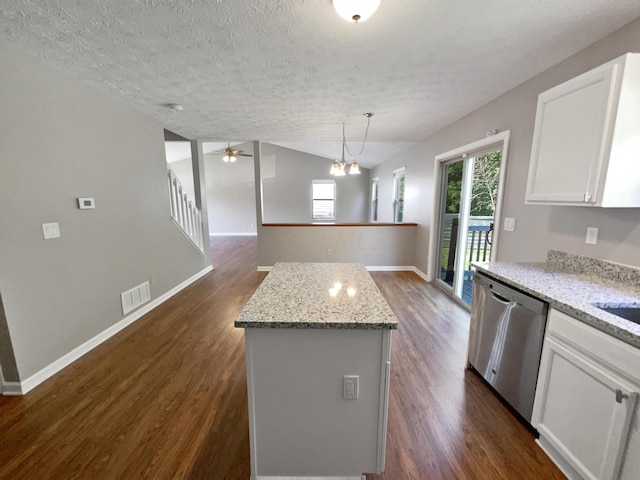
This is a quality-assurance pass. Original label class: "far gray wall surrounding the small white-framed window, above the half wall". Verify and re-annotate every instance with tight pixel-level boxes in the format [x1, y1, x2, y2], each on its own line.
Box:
[261, 143, 370, 223]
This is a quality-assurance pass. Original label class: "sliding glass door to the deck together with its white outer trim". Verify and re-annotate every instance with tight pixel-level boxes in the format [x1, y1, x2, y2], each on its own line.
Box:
[430, 132, 509, 307]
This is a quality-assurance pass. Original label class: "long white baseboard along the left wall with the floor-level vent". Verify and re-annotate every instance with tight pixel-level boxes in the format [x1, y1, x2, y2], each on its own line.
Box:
[15, 266, 213, 395]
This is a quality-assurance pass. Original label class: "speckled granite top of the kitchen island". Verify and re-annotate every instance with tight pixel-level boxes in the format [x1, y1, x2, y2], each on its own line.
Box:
[235, 262, 398, 329]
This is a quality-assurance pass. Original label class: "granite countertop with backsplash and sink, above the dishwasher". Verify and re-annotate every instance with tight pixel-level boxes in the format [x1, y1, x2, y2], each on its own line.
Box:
[473, 250, 640, 348]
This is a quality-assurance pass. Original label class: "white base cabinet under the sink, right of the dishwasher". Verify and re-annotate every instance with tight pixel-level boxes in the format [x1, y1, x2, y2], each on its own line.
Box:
[532, 310, 640, 480]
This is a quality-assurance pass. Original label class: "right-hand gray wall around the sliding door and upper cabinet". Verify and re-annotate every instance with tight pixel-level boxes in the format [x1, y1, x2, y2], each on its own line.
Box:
[371, 19, 640, 272]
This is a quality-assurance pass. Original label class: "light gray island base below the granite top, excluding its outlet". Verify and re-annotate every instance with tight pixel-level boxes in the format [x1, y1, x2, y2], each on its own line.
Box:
[245, 328, 391, 480]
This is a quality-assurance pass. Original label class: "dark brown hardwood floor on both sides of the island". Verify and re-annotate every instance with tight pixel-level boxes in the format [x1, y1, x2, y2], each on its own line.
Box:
[0, 237, 564, 480]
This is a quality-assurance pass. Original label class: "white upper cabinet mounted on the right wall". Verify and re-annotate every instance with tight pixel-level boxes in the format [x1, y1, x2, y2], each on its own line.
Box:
[525, 53, 640, 207]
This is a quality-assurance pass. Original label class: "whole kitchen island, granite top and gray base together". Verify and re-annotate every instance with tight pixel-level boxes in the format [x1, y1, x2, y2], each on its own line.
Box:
[235, 263, 398, 480]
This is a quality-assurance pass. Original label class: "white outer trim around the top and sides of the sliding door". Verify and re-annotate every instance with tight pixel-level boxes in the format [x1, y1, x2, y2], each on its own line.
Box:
[427, 130, 511, 282]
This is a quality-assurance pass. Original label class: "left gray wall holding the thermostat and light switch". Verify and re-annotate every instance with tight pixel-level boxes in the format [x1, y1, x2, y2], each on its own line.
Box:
[0, 47, 210, 381]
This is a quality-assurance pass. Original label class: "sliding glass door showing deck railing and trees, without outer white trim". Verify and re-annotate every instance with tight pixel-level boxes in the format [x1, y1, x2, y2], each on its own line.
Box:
[436, 148, 502, 304]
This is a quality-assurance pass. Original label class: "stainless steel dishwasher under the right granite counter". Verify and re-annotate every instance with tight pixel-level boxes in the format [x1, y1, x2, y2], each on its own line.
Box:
[468, 273, 548, 422]
